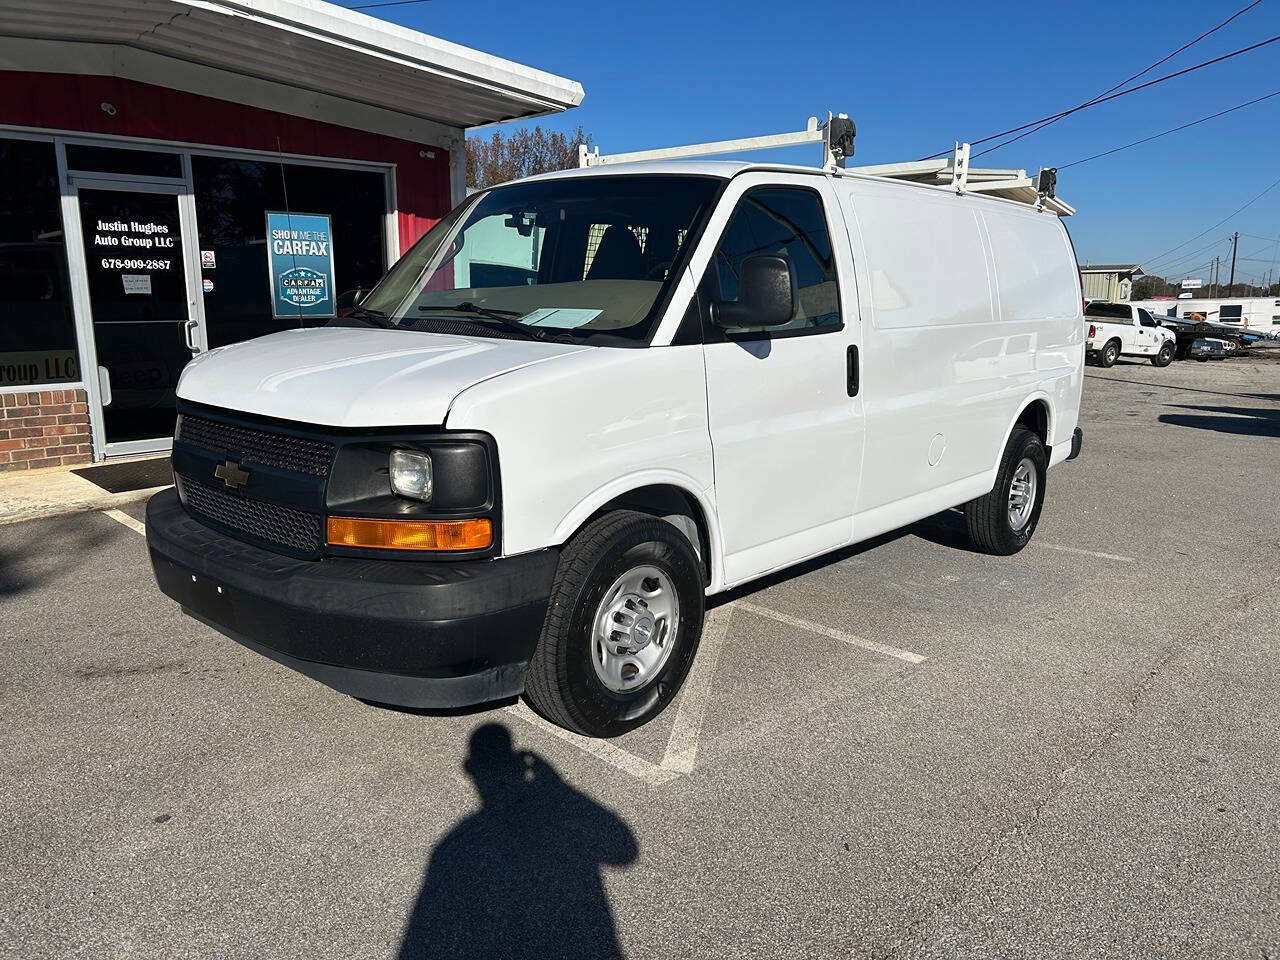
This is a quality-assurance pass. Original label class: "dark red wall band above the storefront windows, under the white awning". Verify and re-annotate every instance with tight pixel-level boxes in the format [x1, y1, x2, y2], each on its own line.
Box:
[0, 70, 451, 252]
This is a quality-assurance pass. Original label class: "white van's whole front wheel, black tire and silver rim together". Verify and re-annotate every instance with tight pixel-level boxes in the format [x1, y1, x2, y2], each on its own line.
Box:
[525, 511, 704, 737]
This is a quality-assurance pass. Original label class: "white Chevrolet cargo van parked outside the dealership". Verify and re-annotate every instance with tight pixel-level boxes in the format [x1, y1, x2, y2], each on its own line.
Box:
[147, 161, 1084, 736]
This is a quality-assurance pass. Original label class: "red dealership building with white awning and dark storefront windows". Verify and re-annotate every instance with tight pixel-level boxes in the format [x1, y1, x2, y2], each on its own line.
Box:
[0, 0, 582, 471]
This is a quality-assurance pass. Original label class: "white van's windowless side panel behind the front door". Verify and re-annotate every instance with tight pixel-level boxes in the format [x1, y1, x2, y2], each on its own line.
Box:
[836, 179, 1083, 527]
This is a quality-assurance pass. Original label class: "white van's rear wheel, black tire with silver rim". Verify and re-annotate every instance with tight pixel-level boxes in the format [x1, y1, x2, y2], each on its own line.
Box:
[964, 426, 1048, 557]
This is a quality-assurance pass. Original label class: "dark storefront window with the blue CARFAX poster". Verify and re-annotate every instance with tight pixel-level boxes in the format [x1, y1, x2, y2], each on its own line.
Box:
[191, 156, 387, 347]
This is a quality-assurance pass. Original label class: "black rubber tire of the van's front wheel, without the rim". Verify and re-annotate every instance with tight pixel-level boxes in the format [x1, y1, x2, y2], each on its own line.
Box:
[525, 511, 705, 737]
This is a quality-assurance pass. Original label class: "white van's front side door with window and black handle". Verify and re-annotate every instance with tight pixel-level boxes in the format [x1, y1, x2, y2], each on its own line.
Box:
[694, 173, 863, 584]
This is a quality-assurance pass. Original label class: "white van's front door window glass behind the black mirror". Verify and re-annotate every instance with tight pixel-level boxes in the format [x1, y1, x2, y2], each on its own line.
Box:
[698, 187, 842, 339]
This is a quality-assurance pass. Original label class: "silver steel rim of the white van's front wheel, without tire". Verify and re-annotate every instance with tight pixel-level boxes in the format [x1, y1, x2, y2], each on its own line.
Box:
[591, 564, 680, 694]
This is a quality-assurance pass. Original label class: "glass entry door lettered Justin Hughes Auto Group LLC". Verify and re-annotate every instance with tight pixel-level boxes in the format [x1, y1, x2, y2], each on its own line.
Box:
[77, 182, 204, 454]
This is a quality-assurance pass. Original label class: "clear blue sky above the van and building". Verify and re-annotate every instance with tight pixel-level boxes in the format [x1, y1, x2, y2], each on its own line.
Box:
[366, 0, 1280, 285]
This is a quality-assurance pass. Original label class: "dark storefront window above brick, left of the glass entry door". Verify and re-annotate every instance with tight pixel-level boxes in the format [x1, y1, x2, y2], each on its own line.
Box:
[0, 137, 79, 388]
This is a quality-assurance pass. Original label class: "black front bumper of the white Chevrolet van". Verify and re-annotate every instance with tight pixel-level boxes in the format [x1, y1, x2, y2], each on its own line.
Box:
[147, 490, 559, 707]
